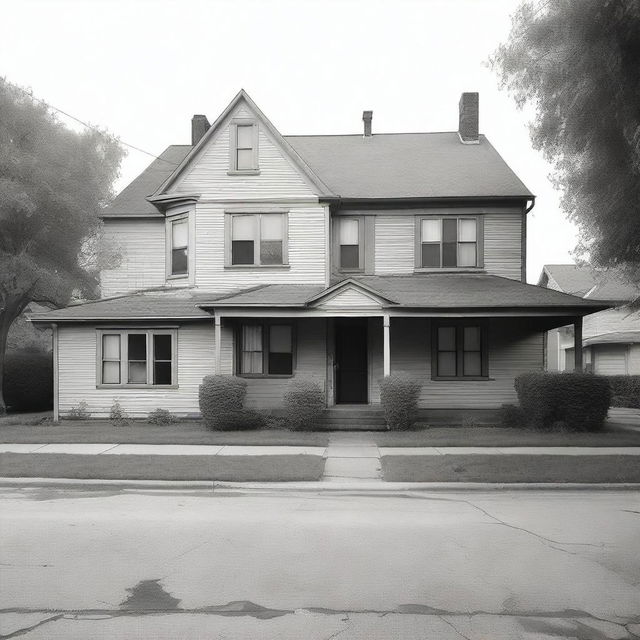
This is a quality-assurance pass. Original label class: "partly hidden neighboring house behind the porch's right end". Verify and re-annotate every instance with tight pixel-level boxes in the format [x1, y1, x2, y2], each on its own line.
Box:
[538, 264, 640, 375]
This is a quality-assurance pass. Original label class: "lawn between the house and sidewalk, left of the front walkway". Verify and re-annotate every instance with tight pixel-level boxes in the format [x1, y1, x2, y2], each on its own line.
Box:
[0, 417, 329, 447]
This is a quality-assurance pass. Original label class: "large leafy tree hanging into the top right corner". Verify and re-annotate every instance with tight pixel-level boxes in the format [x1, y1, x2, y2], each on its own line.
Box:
[490, 0, 640, 284]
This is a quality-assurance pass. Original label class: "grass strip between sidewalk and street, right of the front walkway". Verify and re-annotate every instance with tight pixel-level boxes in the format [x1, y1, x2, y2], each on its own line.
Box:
[380, 454, 640, 483]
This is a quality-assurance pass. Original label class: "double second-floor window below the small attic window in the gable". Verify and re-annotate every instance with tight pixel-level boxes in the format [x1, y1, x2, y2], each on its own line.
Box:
[231, 213, 286, 266]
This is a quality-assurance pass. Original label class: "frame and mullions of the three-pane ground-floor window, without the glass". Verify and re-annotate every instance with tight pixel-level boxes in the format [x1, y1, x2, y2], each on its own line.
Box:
[96, 327, 178, 389]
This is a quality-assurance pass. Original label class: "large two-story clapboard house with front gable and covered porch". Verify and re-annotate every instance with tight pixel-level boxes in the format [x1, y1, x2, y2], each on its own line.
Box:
[33, 91, 606, 416]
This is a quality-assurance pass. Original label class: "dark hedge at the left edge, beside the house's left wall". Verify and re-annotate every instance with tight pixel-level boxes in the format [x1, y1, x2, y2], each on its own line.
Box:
[2, 349, 53, 411]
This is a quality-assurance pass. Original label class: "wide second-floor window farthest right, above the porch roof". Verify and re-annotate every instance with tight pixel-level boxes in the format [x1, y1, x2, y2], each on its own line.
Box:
[419, 217, 478, 269]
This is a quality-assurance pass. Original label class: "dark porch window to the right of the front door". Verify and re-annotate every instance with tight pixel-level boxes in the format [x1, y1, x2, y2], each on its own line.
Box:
[431, 323, 489, 378]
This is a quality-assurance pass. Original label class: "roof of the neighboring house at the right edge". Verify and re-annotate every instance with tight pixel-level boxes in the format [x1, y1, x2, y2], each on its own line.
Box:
[538, 264, 640, 302]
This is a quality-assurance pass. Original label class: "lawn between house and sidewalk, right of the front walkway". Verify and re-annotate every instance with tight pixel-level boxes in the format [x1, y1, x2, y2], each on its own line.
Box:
[371, 427, 640, 447]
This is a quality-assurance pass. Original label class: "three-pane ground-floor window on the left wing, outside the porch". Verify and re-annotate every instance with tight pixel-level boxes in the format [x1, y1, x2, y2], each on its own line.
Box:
[98, 329, 176, 386]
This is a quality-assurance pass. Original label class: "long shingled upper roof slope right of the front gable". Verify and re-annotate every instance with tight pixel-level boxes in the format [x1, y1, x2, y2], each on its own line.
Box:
[286, 132, 533, 199]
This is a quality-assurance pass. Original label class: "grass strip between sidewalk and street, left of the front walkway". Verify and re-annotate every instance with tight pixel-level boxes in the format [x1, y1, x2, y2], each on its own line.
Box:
[0, 453, 325, 482]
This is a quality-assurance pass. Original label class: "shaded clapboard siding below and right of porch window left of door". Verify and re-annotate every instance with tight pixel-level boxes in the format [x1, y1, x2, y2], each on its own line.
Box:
[245, 318, 327, 409]
